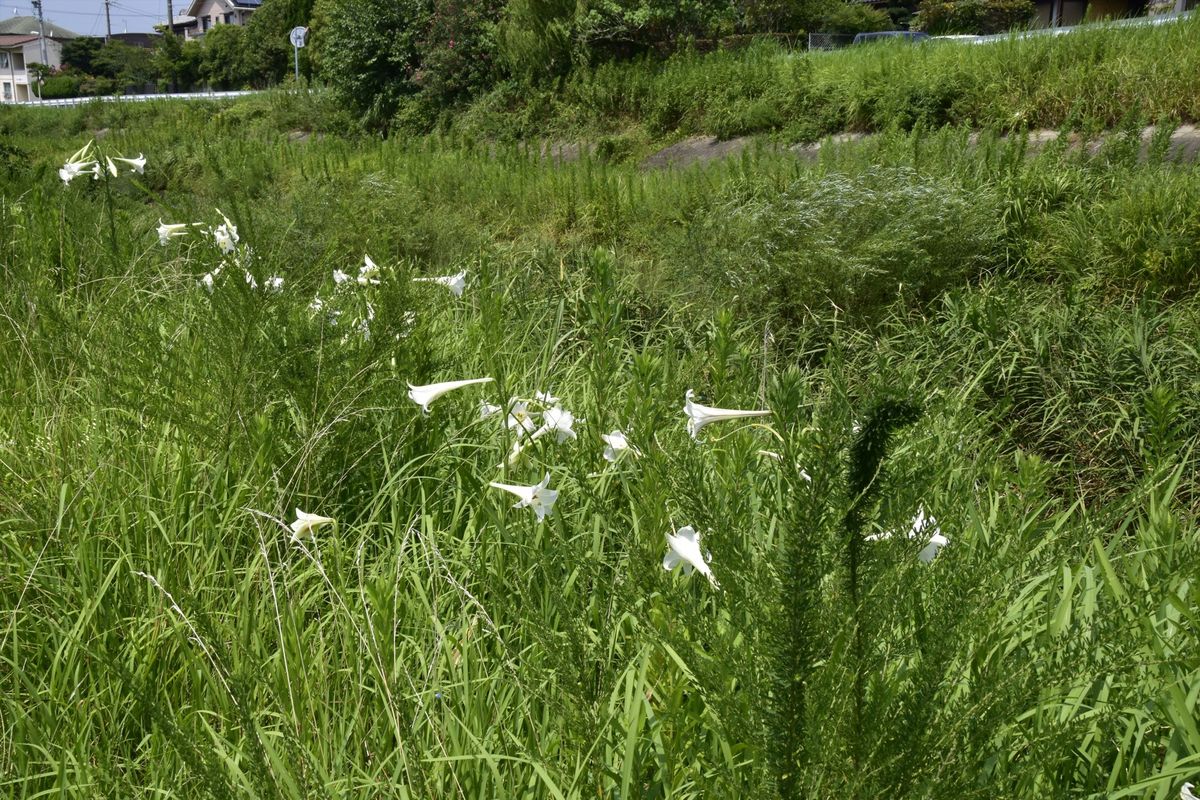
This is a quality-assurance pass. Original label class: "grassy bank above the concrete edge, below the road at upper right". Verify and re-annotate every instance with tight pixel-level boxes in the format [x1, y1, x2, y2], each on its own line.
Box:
[458, 17, 1200, 142]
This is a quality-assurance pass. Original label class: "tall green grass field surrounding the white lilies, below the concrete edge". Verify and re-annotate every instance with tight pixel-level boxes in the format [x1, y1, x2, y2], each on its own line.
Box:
[0, 64, 1200, 798]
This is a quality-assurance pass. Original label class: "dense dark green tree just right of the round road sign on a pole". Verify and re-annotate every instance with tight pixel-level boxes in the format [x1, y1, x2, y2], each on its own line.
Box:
[313, 0, 432, 127]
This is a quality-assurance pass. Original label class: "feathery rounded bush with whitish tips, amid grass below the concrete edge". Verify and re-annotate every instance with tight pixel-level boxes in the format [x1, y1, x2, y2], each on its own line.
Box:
[684, 169, 1002, 320]
